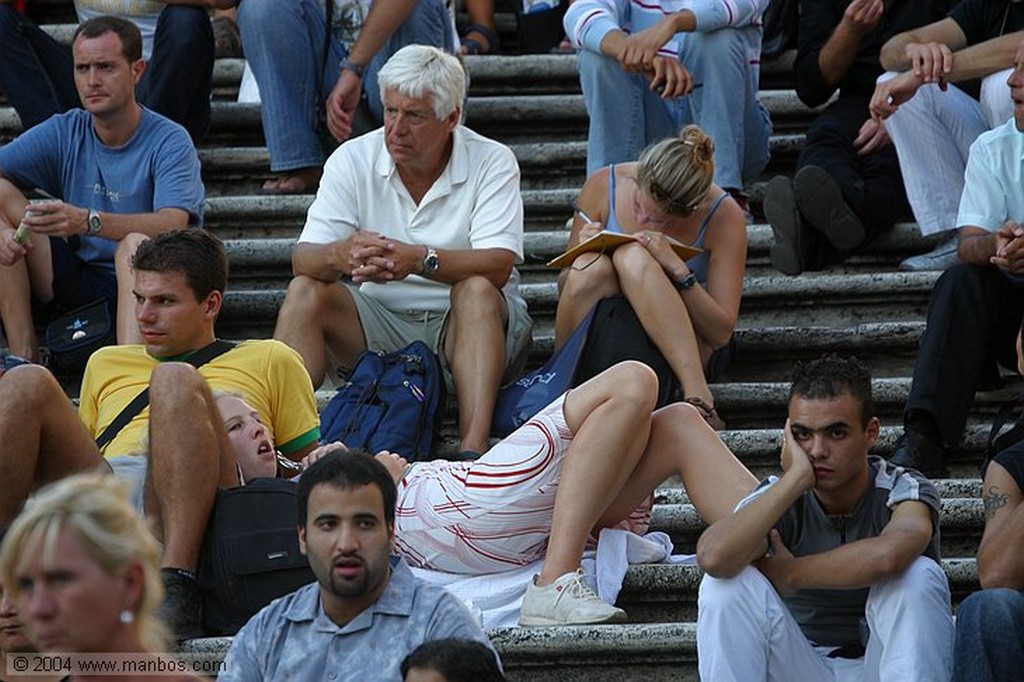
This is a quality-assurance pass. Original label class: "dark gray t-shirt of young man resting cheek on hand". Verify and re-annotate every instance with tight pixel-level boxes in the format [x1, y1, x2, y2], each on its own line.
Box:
[736, 457, 942, 647]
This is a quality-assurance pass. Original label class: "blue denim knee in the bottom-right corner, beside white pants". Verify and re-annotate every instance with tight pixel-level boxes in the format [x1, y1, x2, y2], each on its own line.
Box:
[953, 588, 1024, 682]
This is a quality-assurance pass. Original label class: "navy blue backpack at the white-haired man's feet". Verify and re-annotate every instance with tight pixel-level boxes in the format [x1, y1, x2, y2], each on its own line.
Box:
[321, 341, 443, 462]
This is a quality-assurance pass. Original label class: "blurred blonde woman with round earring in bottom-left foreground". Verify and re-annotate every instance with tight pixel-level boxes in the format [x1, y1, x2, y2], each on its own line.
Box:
[0, 475, 203, 682]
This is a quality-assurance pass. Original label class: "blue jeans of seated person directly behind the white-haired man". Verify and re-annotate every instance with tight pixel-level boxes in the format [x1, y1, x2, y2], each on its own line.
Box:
[239, 0, 455, 172]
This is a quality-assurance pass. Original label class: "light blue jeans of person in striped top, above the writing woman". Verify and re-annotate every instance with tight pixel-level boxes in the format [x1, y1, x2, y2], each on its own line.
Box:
[578, 27, 771, 188]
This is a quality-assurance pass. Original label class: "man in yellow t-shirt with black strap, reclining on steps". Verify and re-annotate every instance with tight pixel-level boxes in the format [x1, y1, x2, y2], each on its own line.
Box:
[0, 229, 319, 639]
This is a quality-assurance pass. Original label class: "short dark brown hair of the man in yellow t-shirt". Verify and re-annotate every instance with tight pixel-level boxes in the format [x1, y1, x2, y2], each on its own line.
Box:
[131, 227, 227, 301]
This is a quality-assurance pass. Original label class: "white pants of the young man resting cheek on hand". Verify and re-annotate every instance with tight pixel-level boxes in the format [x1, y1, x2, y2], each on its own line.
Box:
[697, 557, 953, 682]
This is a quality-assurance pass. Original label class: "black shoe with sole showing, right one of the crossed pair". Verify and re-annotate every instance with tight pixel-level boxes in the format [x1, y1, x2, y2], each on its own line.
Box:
[793, 166, 867, 252]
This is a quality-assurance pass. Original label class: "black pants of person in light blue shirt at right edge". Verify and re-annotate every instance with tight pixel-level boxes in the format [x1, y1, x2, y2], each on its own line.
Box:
[906, 264, 1024, 446]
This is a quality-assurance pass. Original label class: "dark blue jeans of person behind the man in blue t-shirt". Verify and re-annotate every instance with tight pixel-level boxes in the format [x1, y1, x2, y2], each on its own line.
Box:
[0, 4, 214, 141]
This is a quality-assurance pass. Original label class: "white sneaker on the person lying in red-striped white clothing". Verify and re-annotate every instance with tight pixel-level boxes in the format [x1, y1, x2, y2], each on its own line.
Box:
[519, 570, 626, 627]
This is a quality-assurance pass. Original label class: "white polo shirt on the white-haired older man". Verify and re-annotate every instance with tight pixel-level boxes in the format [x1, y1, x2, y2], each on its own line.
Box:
[299, 126, 523, 311]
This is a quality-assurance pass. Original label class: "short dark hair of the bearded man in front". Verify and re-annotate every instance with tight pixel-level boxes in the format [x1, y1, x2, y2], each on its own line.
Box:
[296, 450, 398, 528]
